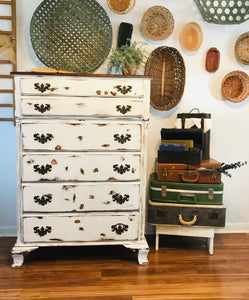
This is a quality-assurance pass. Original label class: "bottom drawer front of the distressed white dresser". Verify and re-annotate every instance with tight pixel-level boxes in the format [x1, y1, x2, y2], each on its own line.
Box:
[23, 214, 139, 242]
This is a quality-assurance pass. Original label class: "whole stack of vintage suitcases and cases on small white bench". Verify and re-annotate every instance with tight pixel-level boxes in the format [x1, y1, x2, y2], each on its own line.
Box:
[148, 113, 226, 227]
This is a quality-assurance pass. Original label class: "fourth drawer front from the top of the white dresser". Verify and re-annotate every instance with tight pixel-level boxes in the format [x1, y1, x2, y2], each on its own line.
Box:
[22, 152, 141, 182]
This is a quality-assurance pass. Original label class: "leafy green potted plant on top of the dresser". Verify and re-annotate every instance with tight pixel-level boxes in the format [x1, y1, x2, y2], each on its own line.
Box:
[108, 42, 148, 75]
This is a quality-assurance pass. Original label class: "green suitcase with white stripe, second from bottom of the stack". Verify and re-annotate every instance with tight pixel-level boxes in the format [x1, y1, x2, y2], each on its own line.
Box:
[150, 173, 223, 205]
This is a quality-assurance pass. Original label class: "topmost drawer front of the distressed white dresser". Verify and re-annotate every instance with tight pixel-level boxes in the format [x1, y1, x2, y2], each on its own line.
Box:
[21, 77, 144, 97]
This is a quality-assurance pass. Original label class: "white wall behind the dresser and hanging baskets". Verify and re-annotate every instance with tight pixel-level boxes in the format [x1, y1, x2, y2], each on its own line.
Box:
[0, 0, 249, 235]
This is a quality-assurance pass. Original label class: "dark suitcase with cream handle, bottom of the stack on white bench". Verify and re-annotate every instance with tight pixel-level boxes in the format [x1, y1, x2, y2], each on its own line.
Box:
[148, 200, 226, 227]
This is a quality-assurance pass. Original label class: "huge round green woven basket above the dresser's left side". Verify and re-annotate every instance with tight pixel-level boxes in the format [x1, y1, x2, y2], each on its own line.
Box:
[30, 0, 112, 73]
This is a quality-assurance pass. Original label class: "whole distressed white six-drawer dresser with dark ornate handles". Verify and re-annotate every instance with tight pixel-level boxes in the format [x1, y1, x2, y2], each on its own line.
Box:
[12, 72, 150, 267]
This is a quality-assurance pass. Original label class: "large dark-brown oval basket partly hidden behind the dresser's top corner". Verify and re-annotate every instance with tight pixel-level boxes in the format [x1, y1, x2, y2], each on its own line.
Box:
[145, 46, 185, 111]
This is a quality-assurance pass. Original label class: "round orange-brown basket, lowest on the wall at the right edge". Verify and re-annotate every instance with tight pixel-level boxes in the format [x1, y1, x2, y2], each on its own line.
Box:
[221, 71, 249, 103]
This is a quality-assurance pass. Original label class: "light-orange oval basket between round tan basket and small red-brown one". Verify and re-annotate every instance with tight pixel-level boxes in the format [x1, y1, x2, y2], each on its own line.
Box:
[180, 22, 203, 52]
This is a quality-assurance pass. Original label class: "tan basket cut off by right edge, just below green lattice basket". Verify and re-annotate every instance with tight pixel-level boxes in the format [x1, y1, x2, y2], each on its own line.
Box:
[234, 31, 249, 65]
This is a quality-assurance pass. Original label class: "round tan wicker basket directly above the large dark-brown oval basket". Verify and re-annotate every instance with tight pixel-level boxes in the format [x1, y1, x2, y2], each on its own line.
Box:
[141, 6, 174, 41]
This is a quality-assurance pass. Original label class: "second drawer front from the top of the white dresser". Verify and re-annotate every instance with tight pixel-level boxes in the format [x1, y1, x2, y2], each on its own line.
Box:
[21, 96, 144, 118]
